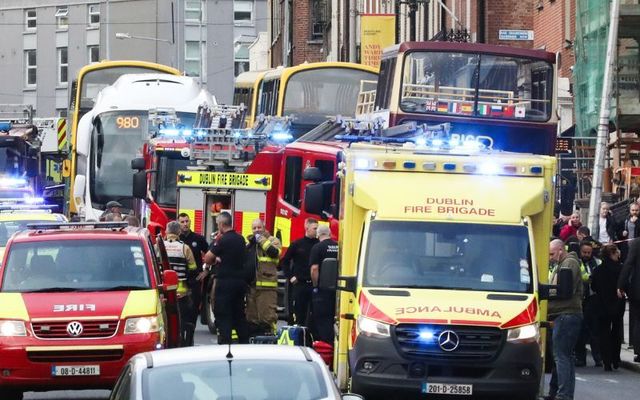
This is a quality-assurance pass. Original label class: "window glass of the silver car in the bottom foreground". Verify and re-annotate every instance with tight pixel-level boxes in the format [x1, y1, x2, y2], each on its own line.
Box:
[142, 360, 328, 400]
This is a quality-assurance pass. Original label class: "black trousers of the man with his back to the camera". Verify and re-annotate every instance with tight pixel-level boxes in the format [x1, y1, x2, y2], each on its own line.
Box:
[213, 278, 249, 344]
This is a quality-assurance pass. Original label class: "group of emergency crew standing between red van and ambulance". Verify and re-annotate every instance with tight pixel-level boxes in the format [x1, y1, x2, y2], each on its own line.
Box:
[155, 212, 338, 346]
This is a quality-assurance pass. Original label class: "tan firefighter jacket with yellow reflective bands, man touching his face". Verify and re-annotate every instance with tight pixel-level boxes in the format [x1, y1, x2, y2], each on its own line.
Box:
[247, 232, 282, 289]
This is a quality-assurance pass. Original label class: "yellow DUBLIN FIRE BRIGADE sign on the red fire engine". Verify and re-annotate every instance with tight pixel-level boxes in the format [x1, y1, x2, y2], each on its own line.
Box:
[178, 171, 271, 190]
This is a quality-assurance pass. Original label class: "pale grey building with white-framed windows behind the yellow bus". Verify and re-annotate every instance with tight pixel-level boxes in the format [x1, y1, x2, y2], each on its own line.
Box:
[0, 0, 267, 117]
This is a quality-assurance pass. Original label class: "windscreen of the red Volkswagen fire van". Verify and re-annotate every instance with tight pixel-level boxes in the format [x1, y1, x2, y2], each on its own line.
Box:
[2, 240, 151, 293]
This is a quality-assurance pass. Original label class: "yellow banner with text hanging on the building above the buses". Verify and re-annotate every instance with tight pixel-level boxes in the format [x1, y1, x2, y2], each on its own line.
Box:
[360, 14, 396, 68]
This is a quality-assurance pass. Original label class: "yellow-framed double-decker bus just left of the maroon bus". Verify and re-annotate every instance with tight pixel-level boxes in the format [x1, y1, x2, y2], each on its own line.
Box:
[251, 62, 378, 140]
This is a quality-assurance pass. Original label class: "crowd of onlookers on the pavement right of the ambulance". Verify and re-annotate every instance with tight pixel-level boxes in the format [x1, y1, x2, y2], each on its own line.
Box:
[547, 202, 640, 400]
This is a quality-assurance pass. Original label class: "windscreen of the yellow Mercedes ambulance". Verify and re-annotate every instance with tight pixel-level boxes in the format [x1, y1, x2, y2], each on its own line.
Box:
[364, 221, 533, 293]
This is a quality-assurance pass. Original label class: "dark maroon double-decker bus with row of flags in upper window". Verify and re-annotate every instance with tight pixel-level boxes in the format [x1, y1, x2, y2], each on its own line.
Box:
[362, 42, 558, 155]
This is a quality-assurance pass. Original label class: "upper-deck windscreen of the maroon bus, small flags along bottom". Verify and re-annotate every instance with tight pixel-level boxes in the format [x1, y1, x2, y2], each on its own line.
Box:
[400, 51, 553, 122]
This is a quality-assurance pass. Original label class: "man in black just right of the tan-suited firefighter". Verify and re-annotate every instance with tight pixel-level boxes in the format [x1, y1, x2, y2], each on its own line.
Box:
[280, 218, 318, 326]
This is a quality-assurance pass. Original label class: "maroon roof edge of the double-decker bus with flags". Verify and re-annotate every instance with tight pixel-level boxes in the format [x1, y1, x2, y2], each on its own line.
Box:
[383, 42, 556, 64]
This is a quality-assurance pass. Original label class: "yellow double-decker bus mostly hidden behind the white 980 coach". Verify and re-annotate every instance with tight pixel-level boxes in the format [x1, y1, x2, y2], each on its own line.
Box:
[63, 60, 182, 214]
